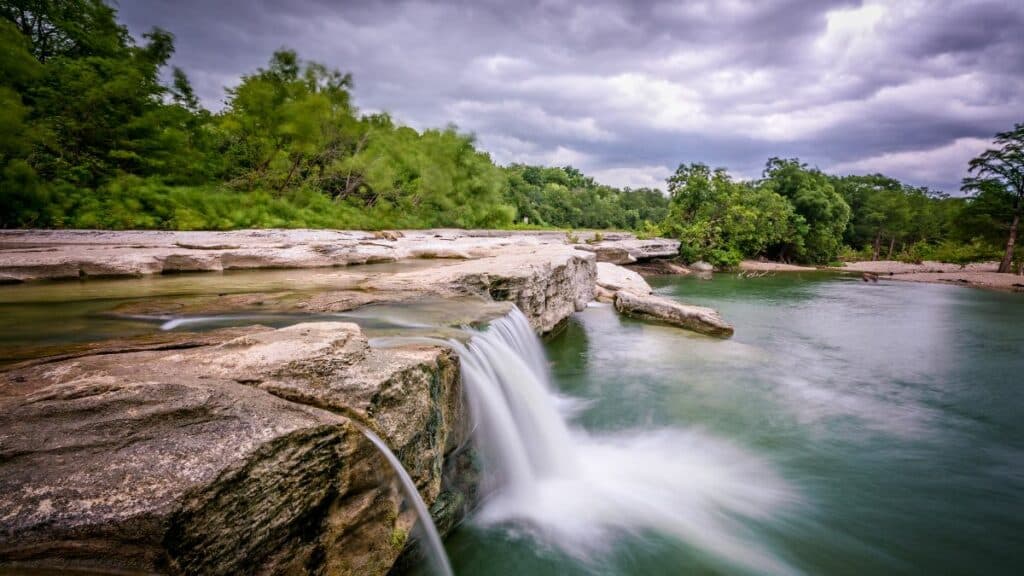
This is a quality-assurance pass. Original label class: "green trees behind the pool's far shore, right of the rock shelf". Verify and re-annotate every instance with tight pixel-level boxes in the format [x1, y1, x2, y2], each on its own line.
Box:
[658, 124, 1024, 272]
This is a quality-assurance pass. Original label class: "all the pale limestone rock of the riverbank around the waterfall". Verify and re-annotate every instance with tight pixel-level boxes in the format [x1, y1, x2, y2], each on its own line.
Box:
[0, 231, 731, 575]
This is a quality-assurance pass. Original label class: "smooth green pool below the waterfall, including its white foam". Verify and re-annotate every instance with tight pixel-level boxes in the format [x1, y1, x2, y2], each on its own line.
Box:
[423, 274, 1024, 576]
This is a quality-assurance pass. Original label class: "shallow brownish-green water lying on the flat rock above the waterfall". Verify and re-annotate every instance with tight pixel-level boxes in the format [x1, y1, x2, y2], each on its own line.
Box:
[0, 260, 499, 364]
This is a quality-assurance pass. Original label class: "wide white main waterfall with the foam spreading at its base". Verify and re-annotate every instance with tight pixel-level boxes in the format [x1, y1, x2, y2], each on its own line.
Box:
[450, 310, 795, 574]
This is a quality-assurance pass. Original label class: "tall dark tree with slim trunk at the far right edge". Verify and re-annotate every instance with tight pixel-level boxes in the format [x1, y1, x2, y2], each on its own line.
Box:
[962, 124, 1024, 273]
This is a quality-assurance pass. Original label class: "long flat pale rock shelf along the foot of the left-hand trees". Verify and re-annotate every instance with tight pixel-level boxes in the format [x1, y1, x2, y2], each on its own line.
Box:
[0, 230, 638, 282]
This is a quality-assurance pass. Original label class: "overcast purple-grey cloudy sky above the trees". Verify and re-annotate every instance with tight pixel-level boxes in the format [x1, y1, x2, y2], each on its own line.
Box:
[120, 0, 1024, 192]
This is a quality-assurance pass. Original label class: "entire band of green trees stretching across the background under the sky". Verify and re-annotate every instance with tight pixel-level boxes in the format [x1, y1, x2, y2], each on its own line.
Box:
[0, 0, 1020, 264]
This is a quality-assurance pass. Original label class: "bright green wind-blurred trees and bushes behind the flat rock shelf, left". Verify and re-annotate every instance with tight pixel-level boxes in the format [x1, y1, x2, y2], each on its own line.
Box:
[0, 0, 667, 229]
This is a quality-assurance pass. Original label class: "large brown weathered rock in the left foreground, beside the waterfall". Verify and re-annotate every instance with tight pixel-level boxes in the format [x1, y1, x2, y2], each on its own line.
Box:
[0, 323, 468, 575]
